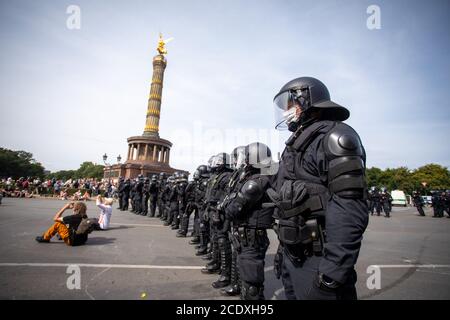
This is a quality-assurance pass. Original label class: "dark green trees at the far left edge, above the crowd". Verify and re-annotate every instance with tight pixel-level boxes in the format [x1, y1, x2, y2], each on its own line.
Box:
[0, 148, 44, 179]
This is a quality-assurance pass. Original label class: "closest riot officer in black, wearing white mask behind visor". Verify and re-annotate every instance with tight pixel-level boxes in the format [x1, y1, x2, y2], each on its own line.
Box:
[268, 77, 368, 299]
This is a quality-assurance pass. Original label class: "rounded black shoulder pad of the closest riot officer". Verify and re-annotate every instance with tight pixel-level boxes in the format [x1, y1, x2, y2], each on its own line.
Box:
[323, 122, 364, 159]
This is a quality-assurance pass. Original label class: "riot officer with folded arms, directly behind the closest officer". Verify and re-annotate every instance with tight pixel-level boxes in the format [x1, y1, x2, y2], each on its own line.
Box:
[223, 142, 273, 300]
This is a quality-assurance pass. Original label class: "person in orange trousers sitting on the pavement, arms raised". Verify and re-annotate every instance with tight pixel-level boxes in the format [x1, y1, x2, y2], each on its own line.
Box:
[36, 202, 88, 246]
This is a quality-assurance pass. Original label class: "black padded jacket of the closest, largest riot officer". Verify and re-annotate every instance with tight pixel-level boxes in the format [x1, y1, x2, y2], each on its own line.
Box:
[275, 120, 368, 283]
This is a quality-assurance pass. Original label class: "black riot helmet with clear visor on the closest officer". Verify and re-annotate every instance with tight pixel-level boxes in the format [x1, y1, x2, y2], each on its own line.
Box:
[273, 77, 350, 131]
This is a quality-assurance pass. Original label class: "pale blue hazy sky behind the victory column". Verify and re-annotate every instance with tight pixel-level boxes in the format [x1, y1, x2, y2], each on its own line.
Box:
[0, 0, 450, 172]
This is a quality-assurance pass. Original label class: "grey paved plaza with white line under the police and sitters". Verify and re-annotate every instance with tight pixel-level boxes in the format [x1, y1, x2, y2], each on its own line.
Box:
[0, 198, 450, 300]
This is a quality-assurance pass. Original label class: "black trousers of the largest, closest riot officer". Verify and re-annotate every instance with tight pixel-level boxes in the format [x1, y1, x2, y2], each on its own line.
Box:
[281, 253, 357, 300]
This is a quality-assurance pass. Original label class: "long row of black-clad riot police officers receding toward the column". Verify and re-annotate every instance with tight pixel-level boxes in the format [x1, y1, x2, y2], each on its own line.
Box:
[119, 77, 369, 300]
